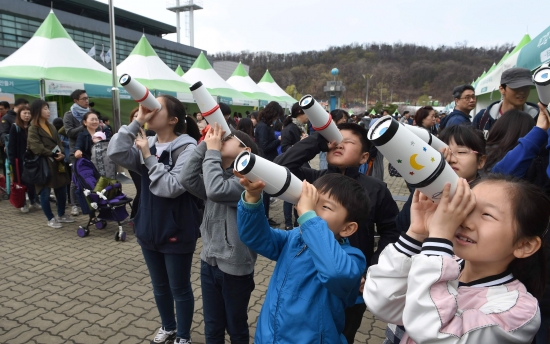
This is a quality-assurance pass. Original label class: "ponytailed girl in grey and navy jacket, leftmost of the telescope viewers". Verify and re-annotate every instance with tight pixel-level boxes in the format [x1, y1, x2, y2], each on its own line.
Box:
[107, 95, 201, 344]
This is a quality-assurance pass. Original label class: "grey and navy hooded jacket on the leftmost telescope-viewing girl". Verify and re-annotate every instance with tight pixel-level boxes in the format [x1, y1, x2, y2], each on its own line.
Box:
[107, 121, 200, 254]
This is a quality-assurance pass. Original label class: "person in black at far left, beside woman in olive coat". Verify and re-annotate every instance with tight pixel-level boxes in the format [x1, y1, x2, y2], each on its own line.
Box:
[8, 104, 40, 213]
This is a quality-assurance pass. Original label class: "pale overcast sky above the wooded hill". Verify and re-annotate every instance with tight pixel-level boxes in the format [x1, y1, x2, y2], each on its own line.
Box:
[99, 0, 550, 54]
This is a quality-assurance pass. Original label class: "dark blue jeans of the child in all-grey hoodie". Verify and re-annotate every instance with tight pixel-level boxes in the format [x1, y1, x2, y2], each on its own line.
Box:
[201, 260, 255, 344]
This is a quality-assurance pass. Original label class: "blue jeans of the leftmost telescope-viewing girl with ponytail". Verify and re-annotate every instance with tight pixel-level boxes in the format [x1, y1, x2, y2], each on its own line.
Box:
[141, 247, 195, 340]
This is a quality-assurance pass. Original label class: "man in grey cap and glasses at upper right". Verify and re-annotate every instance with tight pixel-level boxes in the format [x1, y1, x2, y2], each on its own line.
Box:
[473, 68, 539, 133]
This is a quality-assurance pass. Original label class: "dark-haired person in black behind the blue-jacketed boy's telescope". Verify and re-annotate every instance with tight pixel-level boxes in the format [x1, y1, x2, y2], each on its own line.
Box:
[254, 102, 284, 226]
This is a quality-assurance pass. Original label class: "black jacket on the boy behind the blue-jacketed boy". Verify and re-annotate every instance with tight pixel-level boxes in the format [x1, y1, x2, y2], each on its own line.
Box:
[275, 133, 399, 265]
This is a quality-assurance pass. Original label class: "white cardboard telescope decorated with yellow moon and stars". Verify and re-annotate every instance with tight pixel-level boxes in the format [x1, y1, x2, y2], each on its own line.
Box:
[368, 116, 458, 203]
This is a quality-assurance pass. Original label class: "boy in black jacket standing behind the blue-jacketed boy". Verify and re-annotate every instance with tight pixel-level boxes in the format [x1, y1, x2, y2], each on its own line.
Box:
[275, 123, 399, 343]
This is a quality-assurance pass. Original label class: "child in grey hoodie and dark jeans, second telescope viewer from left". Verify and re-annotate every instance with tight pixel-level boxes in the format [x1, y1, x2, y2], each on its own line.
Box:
[178, 124, 258, 344]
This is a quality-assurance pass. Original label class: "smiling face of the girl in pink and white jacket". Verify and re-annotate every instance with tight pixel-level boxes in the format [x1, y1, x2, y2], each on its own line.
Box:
[453, 182, 516, 268]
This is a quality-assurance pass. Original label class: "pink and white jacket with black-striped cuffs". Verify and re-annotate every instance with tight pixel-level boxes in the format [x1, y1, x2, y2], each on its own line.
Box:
[363, 234, 540, 344]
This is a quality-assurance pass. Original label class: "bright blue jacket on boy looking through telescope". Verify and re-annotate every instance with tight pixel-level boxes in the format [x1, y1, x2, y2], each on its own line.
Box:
[237, 198, 366, 344]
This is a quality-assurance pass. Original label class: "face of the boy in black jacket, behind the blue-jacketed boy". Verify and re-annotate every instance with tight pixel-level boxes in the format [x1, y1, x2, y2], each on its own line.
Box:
[327, 130, 369, 168]
